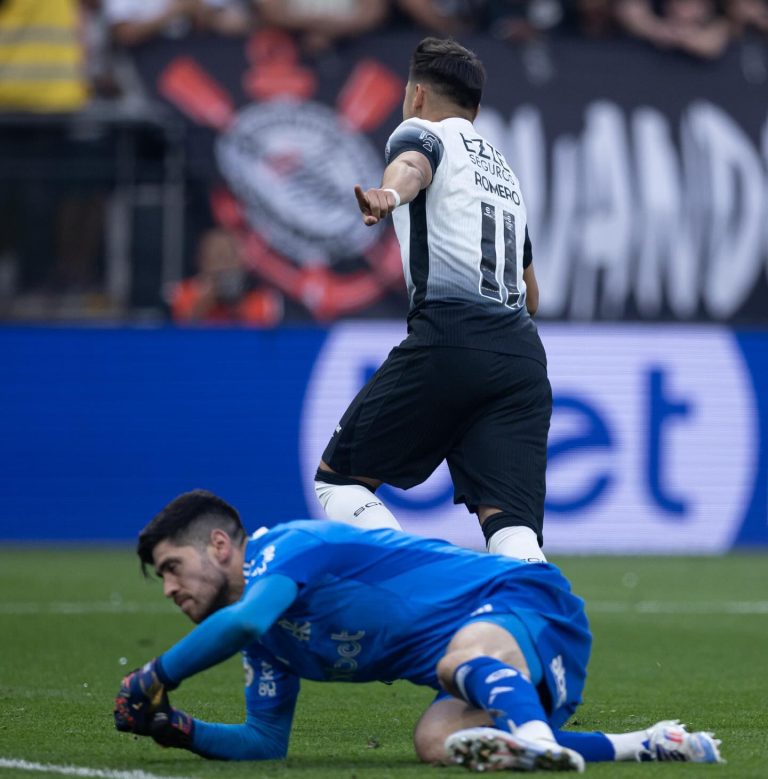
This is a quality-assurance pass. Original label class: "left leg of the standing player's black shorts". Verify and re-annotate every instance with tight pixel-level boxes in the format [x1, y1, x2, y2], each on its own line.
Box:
[323, 348, 460, 488]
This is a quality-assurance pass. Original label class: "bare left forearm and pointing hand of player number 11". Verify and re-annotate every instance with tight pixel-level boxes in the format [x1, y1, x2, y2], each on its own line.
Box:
[355, 151, 432, 226]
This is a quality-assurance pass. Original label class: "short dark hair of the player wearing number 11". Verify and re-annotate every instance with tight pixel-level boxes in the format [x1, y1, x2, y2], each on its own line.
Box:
[408, 38, 485, 110]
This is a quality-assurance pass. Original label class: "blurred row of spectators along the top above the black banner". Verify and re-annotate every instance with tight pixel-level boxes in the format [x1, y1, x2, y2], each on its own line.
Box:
[0, 0, 768, 115]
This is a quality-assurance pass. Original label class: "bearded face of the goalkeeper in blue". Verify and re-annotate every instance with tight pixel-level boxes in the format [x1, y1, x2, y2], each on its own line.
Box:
[153, 541, 233, 623]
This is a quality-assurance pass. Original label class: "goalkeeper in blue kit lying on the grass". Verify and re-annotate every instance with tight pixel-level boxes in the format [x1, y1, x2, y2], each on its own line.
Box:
[115, 490, 720, 771]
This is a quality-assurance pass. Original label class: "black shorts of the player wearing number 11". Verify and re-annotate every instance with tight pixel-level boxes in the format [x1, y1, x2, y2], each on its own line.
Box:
[323, 346, 552, 533]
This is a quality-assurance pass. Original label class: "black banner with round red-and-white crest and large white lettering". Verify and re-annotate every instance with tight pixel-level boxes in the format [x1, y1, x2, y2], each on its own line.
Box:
[136, 30, 768, 324]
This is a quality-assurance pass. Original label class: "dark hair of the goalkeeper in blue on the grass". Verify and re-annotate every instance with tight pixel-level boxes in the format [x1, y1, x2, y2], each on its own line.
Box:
[136, 490, 246, 576]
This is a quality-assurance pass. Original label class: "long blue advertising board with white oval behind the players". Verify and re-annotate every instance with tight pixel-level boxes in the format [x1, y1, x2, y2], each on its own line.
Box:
[0, 321, 768, 554]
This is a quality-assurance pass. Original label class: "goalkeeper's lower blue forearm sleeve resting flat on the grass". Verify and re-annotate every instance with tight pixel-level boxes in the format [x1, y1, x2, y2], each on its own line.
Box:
[192, 698, 296, 760]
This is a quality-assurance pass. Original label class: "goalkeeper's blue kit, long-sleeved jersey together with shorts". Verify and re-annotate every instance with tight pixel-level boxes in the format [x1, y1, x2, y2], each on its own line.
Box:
[160, 520, 591, 758]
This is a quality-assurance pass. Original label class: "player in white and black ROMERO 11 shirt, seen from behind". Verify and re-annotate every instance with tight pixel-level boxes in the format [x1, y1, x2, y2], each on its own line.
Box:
[315, 38, 552, 561]
